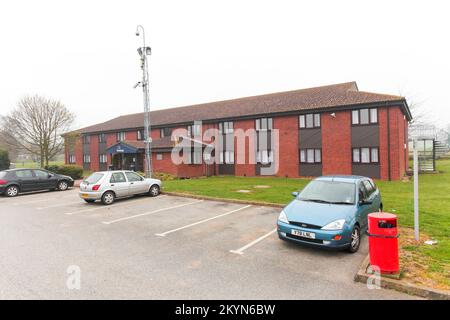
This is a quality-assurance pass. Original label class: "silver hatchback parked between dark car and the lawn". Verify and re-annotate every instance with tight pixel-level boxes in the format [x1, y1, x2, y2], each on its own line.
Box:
[79, 170, 161, 205]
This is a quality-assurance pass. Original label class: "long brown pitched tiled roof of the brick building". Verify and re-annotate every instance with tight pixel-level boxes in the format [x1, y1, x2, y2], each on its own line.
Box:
[73, 82, 410, 133]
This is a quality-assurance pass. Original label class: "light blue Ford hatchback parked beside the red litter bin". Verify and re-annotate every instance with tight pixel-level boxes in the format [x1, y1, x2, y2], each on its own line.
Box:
[277, 176, 383, 253]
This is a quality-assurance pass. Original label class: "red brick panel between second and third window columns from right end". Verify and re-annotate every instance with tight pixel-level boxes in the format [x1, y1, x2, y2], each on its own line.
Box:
[273, 116, 299, 177]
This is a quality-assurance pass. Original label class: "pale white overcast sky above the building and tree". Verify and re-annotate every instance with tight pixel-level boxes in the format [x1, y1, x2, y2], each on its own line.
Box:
[0, 0, 450, 128]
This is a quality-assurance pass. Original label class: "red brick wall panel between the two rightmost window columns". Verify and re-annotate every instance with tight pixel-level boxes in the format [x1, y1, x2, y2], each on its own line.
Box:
[321, 111, 352, 175]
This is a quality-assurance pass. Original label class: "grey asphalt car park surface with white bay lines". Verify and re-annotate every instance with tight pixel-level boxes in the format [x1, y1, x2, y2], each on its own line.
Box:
[0, 188, 414, 299]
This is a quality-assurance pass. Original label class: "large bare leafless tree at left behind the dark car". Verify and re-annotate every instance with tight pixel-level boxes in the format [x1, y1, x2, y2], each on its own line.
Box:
[0, 95, 75, 167]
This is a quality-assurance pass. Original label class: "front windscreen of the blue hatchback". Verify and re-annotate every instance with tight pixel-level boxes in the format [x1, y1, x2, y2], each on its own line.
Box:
[298, 180, 355, 204]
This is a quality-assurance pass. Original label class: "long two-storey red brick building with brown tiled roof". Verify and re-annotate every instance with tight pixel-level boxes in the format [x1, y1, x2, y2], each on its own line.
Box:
[65, 82, 411, 180]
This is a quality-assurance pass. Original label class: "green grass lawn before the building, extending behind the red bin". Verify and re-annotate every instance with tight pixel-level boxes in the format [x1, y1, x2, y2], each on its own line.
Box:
[164, 159, 450, 289]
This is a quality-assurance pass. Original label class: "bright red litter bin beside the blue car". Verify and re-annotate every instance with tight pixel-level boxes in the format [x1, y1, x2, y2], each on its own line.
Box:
[367, 212, 399, 274]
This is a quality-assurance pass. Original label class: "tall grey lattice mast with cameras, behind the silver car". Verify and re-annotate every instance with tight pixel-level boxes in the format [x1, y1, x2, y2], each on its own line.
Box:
[135, 25, 152, 178]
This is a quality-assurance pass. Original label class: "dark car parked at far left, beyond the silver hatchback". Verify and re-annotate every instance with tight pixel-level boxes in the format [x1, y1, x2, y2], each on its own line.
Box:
[0, 169, 73, 197]
